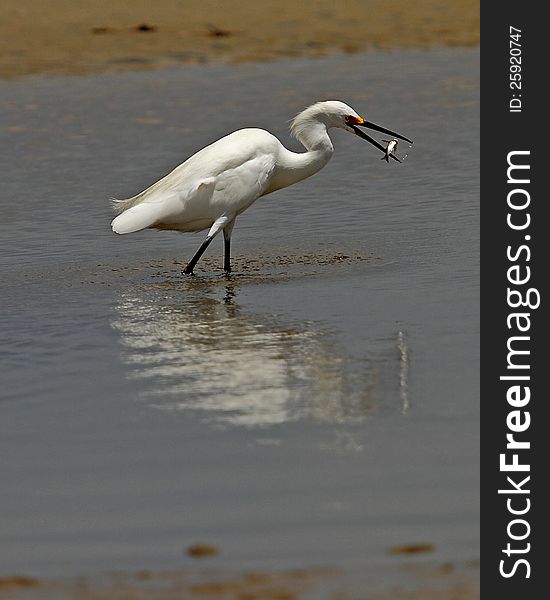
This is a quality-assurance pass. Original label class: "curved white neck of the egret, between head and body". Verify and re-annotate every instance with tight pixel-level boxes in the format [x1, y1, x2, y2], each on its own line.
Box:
[279, 123, 334, 187]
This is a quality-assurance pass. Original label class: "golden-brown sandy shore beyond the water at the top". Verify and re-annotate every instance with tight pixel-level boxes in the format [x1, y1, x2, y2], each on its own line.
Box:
[0, 0, 479, 78]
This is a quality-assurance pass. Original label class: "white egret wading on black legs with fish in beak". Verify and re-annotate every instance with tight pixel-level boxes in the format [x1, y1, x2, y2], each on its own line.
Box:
[111, 100, 412, 274]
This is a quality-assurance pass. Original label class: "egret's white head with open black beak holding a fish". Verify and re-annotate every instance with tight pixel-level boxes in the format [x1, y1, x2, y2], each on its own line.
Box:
[292, 100, 412, 162]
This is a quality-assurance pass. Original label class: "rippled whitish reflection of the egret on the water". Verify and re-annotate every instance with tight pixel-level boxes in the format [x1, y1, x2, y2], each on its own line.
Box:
[112, 281, 408, 427]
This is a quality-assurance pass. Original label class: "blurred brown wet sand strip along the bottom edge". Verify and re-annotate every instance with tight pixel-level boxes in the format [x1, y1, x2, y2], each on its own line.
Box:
[0, 564, 479, 600]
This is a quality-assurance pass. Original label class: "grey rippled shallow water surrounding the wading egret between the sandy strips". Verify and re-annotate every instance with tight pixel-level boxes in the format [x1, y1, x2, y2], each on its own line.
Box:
[0, 50, 479, 575]
